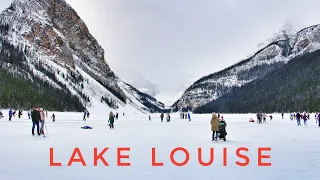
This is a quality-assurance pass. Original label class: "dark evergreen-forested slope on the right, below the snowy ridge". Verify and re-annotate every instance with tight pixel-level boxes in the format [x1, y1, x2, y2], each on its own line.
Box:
[194, 50, 320, 113]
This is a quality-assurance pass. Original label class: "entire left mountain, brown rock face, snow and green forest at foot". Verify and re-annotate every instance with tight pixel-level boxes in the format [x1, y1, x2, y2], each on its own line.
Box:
[0, 0, 164, 112]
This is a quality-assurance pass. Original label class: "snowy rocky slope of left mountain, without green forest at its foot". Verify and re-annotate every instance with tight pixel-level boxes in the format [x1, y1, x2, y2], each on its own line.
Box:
[0, 0, 164, 112]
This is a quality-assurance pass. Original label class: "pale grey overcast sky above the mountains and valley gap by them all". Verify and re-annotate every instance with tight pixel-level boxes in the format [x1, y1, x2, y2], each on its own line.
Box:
[0, 0, 320, 101]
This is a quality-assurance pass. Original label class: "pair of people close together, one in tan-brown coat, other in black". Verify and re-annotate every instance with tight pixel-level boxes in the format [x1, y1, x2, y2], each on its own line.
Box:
[211, 113, 227, 142]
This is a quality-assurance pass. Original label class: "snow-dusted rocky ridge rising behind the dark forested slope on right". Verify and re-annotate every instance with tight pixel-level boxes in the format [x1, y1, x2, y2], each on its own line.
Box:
[172, 25, 320, 111]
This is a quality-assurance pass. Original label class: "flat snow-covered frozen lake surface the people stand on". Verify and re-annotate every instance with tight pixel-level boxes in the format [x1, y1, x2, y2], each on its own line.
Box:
[0, 112, 320, 180]
